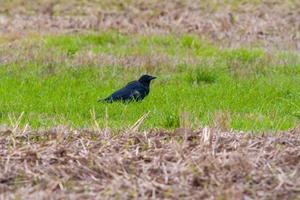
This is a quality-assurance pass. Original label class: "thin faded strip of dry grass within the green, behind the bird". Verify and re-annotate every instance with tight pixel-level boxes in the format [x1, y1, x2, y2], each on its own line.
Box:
[0, 43, 200, 73]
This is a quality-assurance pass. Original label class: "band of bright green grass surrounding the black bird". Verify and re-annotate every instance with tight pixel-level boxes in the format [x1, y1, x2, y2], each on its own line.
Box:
[0, 32, 300, 130]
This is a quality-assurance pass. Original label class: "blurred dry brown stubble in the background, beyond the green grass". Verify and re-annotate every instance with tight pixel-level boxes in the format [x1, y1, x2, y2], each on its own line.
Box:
[0, 0, 300, 50]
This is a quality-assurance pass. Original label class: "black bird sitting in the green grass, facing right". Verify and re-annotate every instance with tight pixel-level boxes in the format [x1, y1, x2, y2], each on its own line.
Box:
[98, 74, 156, 103]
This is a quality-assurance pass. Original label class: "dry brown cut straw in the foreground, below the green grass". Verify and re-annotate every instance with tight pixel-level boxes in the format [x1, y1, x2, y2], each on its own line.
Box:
[0, 126, 300, 199]
